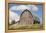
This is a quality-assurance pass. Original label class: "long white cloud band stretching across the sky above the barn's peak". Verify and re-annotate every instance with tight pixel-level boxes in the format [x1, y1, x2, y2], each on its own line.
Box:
[10, 5, 38, 11]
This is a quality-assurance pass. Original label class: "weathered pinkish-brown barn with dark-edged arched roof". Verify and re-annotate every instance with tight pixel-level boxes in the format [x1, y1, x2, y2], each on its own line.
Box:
[20, 9, 34, 25]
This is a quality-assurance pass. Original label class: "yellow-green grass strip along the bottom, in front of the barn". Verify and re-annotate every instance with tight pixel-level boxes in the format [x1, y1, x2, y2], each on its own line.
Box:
[9, 24, 42, 30]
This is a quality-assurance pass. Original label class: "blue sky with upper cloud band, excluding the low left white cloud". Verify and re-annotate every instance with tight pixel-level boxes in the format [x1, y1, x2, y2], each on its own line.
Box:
[9, 4, 42, 22]
